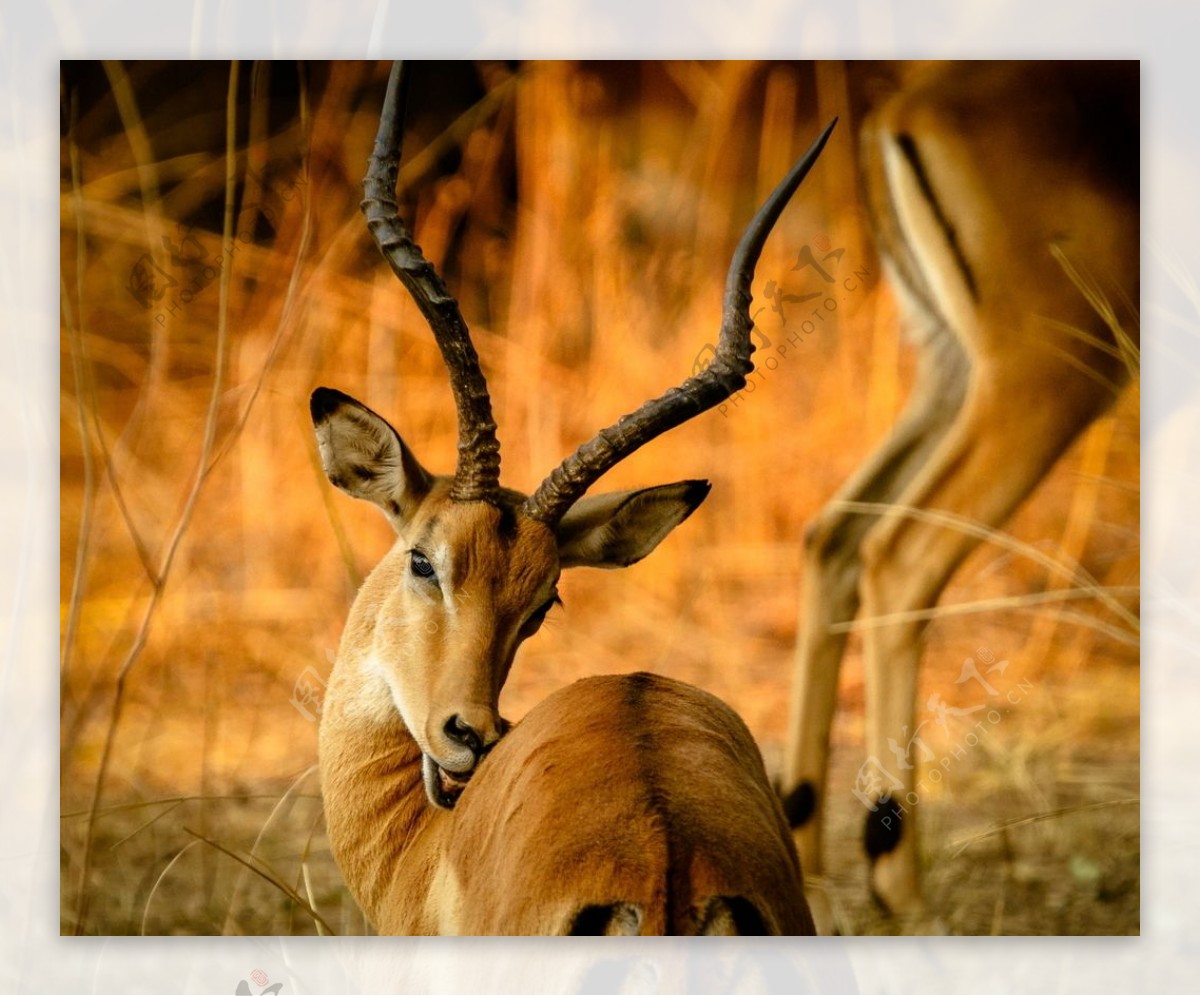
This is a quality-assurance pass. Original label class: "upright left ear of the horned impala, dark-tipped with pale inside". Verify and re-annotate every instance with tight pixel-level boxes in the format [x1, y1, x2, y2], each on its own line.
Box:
[308, 388, 433, 526]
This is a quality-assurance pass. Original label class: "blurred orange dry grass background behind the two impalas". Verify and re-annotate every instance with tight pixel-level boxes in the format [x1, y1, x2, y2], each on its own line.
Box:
[60, 62, 1139, 934]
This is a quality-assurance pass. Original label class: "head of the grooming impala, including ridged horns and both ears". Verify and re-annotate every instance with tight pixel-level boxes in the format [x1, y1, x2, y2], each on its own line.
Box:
[311, 64, 833, 809]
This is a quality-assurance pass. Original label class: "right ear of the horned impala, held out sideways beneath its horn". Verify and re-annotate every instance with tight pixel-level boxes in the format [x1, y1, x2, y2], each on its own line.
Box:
[557, 481, 712, 568]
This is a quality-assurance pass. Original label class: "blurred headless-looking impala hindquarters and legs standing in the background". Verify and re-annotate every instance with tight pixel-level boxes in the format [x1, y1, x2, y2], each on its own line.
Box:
[786, 62, 1139, 910]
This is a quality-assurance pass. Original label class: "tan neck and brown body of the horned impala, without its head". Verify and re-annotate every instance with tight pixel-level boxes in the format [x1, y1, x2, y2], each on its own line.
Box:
[322, 674, 814, 935]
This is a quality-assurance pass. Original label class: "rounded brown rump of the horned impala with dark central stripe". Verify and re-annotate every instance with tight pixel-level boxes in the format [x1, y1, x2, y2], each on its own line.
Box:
[436, 673, 812, 935]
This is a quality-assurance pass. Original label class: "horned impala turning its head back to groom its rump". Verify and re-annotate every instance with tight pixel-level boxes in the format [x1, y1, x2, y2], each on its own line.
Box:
[311, 66, 832, 934]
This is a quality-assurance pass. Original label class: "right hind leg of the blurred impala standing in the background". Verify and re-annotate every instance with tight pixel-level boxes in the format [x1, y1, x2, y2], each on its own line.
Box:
[860, 372, 1108, 912]
